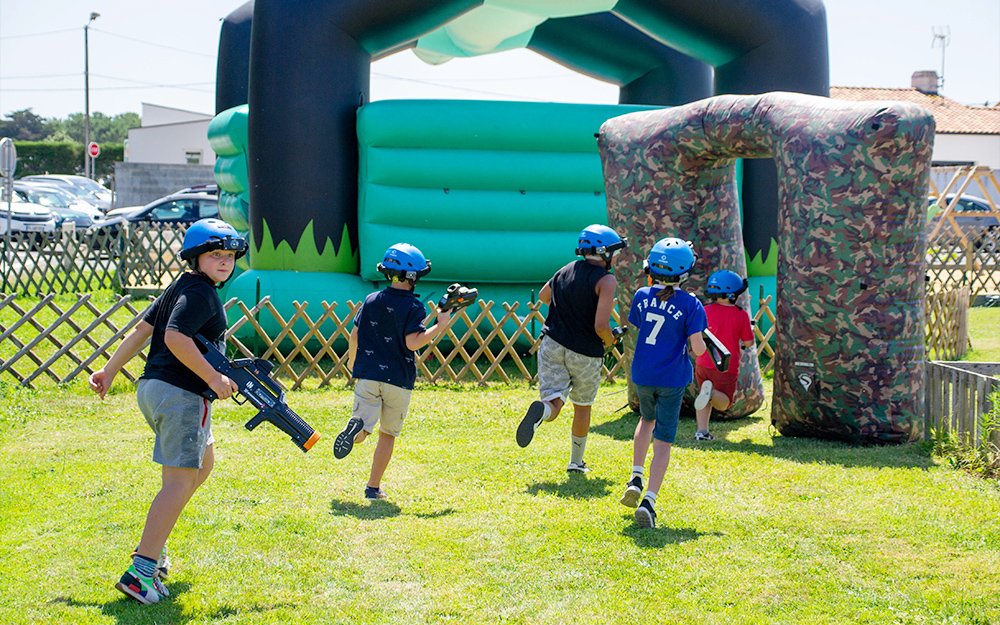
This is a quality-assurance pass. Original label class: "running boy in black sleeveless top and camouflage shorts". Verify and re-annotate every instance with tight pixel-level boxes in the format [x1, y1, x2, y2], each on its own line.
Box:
[516, 224, 628, 473]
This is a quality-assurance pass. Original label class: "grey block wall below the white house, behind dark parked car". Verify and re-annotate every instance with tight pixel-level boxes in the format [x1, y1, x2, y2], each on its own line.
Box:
[115, 162, 215, 207]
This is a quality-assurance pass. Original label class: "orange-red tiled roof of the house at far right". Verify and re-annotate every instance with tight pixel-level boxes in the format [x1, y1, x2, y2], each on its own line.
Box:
[830, 87, 1000, 135]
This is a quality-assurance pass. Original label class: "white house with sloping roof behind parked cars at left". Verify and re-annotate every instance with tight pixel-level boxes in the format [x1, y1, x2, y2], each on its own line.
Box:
[125, 102, 215, 165]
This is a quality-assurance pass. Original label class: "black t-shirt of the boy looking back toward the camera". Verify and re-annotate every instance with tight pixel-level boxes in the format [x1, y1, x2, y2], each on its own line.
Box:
[142, 273, 226, 395]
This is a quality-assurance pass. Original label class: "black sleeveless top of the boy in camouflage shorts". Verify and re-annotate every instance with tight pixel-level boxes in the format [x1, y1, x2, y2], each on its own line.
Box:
[542, 260, 609, 357]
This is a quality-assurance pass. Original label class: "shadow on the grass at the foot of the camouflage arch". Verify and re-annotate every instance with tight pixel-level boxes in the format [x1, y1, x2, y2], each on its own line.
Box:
[590, 412, 934, 469]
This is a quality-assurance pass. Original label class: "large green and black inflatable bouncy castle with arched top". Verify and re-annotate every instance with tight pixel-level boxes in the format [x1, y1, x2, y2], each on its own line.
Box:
[210, 0, 829, 309]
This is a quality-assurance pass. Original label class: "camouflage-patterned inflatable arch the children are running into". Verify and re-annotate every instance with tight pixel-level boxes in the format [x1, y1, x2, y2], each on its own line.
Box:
[599, 93, 934, 442]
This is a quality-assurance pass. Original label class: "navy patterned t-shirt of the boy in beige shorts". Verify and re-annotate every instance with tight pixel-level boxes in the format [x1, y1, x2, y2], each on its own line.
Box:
[352, 287, 425, 389]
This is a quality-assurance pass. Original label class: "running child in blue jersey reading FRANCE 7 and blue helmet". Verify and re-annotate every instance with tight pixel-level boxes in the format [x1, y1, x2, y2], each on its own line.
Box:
[621, 238, 708, 527]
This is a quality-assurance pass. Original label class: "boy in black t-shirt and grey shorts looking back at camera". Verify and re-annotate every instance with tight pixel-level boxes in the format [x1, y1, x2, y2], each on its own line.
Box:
[90, 219, 247, 604]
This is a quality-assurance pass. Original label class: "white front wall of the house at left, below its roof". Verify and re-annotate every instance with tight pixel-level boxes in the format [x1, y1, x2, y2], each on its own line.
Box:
[125, 119, 215, 166]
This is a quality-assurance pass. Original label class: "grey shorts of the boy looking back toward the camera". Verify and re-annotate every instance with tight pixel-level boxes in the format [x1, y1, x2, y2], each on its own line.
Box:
[136, 378, 215, 469]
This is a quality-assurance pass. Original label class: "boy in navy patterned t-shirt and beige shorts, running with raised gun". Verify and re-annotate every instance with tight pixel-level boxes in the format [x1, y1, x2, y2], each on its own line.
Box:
[333, 243, 451, 499]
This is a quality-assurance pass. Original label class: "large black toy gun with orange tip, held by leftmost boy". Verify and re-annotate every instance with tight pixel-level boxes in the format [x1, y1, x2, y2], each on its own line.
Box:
[194, 334, 320, 451]
